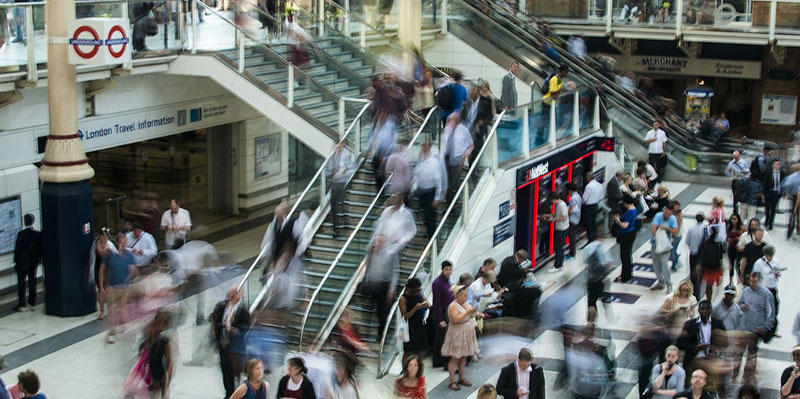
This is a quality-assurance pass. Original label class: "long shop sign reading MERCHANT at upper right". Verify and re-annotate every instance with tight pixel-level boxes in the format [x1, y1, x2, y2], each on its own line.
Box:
[613, 55, 761, 79]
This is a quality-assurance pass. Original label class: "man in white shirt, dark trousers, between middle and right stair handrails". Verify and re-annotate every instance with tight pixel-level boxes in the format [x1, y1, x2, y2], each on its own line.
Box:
[414, 139, 443, 239]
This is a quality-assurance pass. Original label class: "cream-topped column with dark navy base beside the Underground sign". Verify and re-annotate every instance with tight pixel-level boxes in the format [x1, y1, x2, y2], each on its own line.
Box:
[39, 0, 96, 316]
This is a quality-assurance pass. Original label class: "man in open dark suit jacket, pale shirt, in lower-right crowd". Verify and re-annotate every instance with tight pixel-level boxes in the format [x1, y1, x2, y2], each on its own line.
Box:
[677, 299, 728, 373]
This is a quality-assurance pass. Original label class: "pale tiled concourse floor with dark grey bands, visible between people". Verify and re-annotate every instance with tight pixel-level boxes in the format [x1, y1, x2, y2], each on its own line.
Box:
[0, 182, 800, 399]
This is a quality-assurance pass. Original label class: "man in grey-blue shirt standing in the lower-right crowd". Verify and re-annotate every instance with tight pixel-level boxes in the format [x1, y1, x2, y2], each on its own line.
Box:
[734, 272, 775, 383]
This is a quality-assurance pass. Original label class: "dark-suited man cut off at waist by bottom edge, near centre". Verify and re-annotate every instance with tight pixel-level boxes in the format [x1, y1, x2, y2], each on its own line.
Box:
[497, 348, 545, 399]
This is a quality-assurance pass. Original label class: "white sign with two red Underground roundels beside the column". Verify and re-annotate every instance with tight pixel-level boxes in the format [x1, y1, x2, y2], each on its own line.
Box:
[67, 18, 133, 65]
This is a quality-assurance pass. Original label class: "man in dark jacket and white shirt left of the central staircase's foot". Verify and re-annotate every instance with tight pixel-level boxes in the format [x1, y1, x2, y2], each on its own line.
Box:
[211, 287, 250, 398]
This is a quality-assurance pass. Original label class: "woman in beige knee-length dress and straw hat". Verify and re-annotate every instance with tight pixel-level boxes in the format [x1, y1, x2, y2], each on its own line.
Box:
[442, 285, 483, 391]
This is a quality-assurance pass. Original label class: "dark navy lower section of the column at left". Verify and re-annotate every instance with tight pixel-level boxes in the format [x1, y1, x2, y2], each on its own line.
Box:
[41, 180, 97, 317]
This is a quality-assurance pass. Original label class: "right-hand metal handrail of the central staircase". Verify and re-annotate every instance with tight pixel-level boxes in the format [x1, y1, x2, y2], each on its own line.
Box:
[378, 108, 506, 378]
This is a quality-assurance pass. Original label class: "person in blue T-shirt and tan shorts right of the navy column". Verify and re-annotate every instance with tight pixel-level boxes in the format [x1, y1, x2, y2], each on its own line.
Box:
[100, 233, 136, 344]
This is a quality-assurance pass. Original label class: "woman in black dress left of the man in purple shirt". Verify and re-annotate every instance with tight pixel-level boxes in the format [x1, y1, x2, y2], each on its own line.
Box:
[398, 277, 431, 360]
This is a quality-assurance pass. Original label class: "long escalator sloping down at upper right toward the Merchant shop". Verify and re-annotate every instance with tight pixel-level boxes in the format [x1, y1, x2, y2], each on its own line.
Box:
[448, 0, 777, 176]
